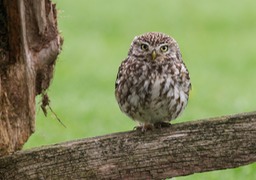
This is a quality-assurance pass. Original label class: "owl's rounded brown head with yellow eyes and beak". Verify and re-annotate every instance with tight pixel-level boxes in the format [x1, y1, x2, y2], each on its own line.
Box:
[128, 32, 182, 62]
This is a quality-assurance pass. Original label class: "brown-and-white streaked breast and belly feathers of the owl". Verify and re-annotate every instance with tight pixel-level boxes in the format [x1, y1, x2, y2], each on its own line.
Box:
[117, 61, 190, 123]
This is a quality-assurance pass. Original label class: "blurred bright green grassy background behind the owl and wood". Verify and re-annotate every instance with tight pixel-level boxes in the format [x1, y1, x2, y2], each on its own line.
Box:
[25, 0, 256, 180]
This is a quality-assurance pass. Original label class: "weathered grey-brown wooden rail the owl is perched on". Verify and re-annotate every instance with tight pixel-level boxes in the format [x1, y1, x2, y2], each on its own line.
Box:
[0, 113, 256, 179]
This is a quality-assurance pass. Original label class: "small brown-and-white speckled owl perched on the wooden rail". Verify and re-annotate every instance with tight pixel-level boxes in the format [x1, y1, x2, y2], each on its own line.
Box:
[115, 32, 191, 132]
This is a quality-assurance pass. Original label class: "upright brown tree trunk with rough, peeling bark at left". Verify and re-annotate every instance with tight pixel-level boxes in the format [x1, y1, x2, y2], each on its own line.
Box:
[0, 0, 61, 156]
